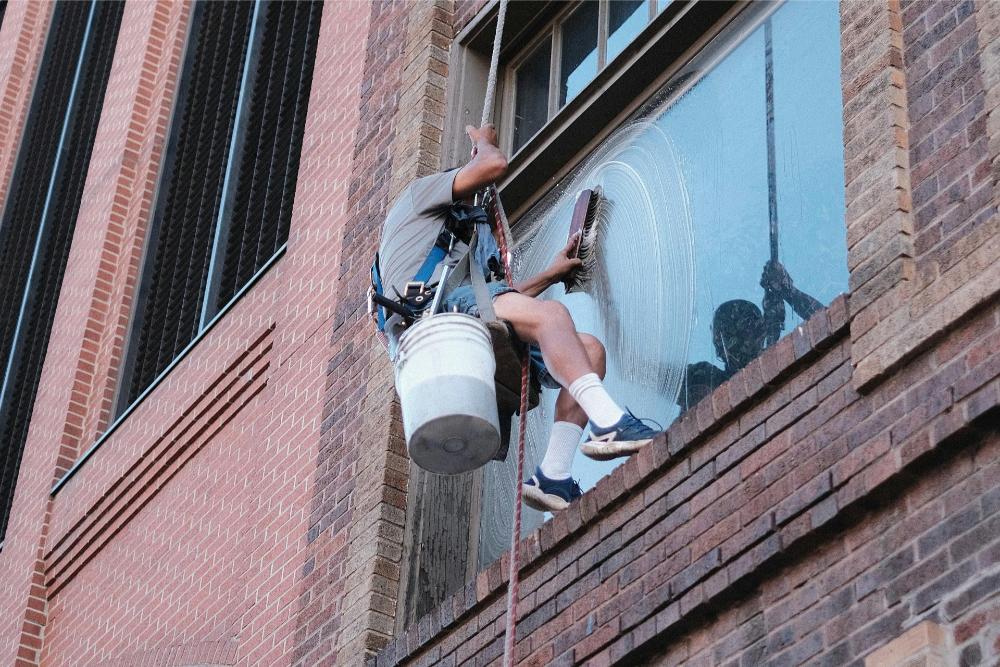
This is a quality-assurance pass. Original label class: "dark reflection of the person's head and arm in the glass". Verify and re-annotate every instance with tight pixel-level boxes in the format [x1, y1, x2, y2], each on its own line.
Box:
[677, 260, 823, 411]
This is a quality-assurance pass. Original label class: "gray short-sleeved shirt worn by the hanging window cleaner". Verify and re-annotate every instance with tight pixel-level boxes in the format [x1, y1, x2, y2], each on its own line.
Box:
[378, 169, 466, 299]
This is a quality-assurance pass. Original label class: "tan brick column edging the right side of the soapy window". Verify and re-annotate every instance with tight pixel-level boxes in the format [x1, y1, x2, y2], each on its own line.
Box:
[841, 0, 914, 386]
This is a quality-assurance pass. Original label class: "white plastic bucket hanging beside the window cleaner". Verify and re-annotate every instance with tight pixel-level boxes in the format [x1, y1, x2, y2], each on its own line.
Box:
[396, 313, 500, 475]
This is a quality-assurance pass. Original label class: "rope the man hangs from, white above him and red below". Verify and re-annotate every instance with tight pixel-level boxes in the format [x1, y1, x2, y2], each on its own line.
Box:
[479, 0, 530, 667]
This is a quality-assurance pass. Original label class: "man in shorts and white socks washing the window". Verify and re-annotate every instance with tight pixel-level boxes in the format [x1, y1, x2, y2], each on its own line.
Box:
[379, 125, 656, 511]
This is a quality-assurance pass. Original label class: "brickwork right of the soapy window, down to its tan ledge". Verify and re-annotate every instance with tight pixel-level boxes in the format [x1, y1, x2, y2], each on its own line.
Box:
[843, 0, 1000, 391]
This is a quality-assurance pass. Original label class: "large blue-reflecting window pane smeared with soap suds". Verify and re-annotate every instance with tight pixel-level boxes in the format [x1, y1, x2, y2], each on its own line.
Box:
[480, 2, 848, 564]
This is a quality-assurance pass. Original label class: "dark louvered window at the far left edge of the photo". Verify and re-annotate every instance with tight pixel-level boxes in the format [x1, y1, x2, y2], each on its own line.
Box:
[0, 2, 124, 536]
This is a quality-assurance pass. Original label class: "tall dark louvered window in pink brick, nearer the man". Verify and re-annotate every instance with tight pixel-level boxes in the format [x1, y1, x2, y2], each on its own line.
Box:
[118, 2, 322, 411]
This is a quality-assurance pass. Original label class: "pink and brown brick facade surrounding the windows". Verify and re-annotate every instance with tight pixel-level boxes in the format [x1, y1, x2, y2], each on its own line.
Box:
[0, 0, 1000, 665]
